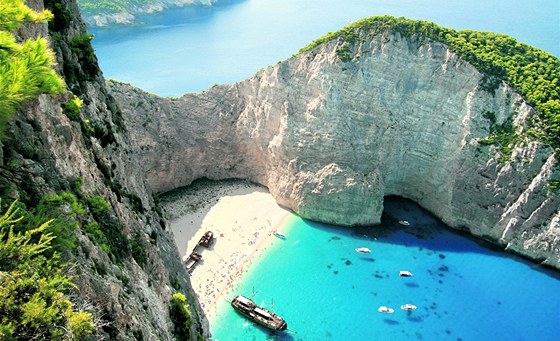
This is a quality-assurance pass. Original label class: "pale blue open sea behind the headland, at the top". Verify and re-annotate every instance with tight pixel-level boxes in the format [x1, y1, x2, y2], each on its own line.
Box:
[91, 0, 560, 96]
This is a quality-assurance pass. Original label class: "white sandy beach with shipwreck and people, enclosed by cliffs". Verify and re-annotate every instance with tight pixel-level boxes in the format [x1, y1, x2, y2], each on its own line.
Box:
[162, 181, 292, 316]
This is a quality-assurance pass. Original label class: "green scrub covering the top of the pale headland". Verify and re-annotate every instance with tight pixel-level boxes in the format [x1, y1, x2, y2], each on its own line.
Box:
[299, 16, 560, 154]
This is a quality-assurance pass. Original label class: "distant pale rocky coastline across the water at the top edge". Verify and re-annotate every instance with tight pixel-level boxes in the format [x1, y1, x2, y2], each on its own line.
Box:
[78, 0, 217, 27]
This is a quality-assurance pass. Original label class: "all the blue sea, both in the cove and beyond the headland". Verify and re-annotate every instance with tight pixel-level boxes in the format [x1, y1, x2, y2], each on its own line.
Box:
[87, 0, 560, 341]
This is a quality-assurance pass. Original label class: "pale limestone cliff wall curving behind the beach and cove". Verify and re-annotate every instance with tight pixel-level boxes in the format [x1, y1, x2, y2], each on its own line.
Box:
[111, 31, 560, 268]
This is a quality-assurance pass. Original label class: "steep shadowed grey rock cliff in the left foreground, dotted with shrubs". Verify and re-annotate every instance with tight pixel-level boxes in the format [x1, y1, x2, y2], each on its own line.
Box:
[1, 0, 208, 340]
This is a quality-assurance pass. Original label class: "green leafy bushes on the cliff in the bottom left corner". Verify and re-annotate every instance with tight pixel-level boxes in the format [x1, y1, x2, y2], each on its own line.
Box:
[0, 202, 95, 340]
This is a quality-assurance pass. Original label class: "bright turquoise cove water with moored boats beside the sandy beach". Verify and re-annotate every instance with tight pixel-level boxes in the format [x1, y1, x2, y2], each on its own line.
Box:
[210, 198, 560, 341]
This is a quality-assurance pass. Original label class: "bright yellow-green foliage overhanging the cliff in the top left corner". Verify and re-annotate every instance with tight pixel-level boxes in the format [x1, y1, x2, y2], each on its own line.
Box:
[0, 0, 64, 137]
